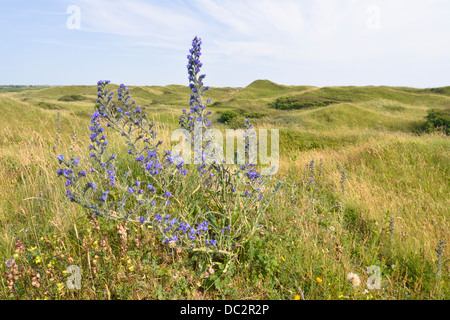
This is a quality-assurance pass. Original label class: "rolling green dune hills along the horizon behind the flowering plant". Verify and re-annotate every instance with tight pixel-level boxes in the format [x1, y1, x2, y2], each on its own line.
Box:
[0, 80, 450, 137]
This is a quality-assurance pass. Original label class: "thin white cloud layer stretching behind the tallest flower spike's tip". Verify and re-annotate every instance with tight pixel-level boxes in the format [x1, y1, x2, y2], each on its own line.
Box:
[66, 0, 450, 61]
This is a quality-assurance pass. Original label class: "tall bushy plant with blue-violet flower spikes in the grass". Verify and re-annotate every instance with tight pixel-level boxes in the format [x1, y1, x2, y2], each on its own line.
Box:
[57, 37, 274, 257]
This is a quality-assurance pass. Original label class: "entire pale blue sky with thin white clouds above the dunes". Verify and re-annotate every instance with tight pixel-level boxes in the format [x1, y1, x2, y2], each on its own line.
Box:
[0, 0, 450, 88]
